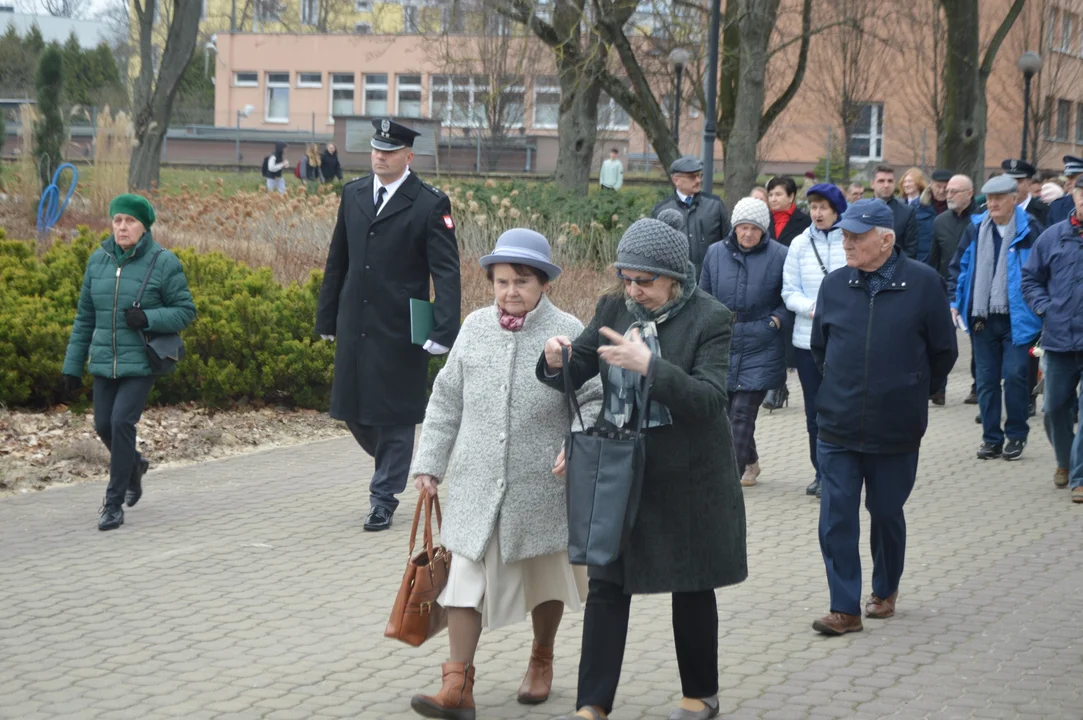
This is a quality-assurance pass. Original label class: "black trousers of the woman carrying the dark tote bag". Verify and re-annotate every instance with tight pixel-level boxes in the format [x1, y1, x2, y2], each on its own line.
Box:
[575, 578, 718, 715]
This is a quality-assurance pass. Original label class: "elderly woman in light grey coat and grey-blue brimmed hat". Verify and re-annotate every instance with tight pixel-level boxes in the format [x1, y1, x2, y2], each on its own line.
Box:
[410, 228, 601, 720]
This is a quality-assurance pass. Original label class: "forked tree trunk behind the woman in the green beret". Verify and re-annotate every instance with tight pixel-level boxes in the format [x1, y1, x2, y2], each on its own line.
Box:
[128, 0, 201, 191]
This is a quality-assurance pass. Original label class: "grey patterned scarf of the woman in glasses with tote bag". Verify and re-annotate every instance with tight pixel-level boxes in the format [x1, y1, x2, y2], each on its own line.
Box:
[604, 263, 696, 428]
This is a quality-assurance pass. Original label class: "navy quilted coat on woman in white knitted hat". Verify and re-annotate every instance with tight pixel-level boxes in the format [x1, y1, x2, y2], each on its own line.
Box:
[700, 233, 794, 392]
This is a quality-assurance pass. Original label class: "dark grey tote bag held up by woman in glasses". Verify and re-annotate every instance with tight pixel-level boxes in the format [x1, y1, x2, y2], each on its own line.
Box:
[561, 348, 654, 566]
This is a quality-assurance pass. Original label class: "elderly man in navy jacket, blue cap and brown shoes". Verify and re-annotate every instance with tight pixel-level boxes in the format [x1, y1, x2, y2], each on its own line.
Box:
[810, 200, 958, 636]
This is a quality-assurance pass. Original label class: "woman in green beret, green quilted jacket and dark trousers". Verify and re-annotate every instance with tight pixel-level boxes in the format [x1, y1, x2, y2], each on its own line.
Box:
[64, 195, 196, 531]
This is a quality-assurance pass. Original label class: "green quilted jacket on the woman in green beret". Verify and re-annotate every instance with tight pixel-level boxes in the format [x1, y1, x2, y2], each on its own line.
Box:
[63, 232, 196, 378]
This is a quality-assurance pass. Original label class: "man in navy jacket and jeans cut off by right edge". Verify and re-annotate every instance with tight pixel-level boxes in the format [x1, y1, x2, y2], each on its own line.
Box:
[1022, 175, 1083, 503]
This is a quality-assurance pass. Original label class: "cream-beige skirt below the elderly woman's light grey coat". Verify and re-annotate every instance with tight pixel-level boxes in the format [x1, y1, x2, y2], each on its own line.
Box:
[436, 526, 587, 630]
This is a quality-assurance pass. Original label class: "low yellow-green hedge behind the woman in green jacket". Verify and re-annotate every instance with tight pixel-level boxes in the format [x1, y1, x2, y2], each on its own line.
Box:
[0, 228, 443, 410]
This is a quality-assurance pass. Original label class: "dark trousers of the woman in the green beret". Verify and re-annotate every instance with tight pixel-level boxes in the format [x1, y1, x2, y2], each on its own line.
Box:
[94, 376, 154, 505]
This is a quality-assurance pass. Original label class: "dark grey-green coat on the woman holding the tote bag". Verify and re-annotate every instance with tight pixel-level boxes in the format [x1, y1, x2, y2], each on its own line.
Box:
[537, 289, 748, 593]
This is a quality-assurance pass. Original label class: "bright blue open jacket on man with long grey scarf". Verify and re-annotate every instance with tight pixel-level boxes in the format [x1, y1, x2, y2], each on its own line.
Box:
[948, 207, 1042, 345]
